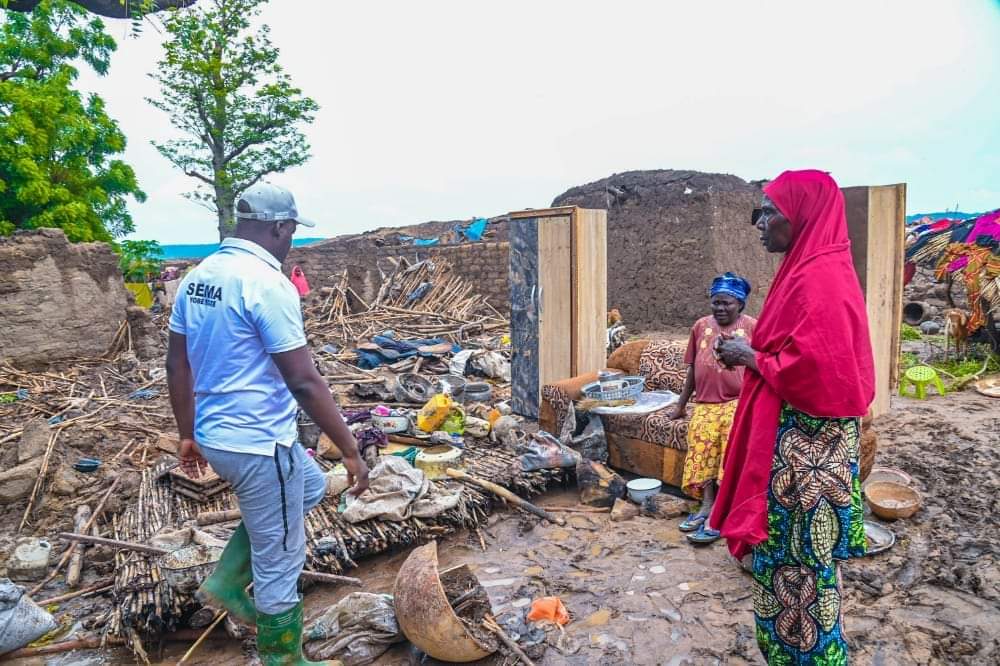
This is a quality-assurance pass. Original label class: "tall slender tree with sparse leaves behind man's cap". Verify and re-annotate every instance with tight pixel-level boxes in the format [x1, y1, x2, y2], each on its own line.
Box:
[148, 0, 319, 239]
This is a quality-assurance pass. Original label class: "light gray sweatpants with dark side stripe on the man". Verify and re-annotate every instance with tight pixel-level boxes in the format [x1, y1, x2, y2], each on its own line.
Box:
[201, 444, 326, 615]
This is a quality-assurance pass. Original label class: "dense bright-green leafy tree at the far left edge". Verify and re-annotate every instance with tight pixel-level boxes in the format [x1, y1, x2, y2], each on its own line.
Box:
[0, 0, 145, 241]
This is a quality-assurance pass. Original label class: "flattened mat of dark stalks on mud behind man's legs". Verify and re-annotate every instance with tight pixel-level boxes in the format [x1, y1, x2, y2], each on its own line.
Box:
[105, 441, 565, 654]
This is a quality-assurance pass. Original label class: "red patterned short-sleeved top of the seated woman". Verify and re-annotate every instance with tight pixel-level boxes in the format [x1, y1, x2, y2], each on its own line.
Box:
[684, 314, 757, 403]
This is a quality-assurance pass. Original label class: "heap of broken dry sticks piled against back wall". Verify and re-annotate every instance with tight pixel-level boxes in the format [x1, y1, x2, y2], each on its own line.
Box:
[304, 258, 510, 347]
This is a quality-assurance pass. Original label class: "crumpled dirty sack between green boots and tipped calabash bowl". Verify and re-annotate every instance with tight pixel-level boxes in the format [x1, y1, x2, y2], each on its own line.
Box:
[302, 592, 403, 666]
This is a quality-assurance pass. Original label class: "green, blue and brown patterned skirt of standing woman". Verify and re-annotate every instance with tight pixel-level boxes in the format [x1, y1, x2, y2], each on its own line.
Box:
[753, 405, 867, 665]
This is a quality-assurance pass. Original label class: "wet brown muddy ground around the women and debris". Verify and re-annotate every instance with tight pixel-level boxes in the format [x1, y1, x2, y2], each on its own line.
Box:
[5, 384, 1000, 666]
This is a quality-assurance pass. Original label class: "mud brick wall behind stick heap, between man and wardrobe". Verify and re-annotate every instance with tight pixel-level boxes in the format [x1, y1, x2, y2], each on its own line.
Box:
[285, 236, 510, 313]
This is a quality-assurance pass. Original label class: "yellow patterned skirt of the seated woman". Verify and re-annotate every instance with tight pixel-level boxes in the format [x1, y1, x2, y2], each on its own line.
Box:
[681, 400, 737, 499]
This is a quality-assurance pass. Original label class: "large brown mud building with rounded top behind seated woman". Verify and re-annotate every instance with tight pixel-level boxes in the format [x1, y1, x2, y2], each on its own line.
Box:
[552, 170, 778, 331]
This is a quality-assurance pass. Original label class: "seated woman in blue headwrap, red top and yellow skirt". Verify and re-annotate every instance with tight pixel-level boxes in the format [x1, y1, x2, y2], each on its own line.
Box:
[671, 273, 757, 544]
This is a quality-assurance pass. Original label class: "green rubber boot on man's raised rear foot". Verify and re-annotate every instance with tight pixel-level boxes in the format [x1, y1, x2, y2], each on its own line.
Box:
[196, 521, 257, 627]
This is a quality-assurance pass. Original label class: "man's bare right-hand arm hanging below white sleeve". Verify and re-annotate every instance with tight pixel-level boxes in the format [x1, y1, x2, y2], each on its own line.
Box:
[271, 347, 368, 495]
